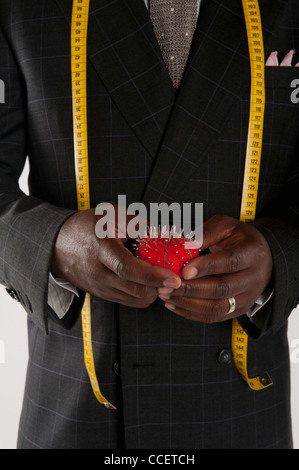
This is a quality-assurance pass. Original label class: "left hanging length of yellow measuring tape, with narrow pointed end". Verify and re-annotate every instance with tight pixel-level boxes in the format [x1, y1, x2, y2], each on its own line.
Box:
[71, 0, 116, 409]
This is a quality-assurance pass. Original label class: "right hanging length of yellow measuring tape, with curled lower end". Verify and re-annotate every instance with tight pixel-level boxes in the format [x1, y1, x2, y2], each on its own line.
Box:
[232, 0, 273, 390]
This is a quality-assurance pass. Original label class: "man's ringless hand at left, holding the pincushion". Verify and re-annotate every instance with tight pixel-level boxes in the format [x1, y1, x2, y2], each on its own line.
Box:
[51, 206, 181, 308]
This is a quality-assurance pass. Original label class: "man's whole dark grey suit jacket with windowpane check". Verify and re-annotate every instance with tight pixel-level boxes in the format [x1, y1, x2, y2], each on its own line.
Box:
[0, 0, 299, 449]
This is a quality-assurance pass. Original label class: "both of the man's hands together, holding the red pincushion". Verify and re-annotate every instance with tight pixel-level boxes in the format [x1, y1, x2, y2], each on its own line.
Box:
[52, 210, 273, 323]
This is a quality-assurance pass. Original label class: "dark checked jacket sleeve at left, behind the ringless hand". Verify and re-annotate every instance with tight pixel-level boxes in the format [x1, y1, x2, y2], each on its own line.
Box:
[0, 26, 80, 331]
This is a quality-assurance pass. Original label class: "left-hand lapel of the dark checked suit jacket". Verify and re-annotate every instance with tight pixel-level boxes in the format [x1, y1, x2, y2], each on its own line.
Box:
[55, 0, 176, 158]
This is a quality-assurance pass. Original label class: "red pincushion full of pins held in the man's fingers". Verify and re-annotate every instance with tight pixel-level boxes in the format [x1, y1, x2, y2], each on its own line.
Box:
[135, 236, 199, 277]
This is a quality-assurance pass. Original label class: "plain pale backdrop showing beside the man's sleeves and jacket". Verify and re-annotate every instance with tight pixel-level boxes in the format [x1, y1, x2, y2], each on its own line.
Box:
[0, 161, 299, 449]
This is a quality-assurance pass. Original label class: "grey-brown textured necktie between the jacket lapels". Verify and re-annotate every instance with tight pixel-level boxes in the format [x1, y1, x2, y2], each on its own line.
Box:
[150, 0, 198, 88]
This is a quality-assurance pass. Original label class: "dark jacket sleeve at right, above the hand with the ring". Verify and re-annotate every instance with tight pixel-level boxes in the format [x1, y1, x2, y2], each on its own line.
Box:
[240, 143, 299, 338]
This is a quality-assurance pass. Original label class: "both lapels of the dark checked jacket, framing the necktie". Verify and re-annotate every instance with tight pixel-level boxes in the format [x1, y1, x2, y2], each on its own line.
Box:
[55, 0, 288, 203]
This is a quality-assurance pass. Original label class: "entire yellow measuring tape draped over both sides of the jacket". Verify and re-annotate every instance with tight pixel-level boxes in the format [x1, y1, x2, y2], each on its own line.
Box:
[71, 0, 272, 409]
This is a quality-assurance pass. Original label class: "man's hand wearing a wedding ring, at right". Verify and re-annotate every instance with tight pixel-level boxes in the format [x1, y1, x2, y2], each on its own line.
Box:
[159, 215, 273, 323]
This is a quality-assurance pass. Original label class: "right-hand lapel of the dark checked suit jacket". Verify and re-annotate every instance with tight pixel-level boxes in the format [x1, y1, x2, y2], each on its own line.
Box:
[143, 0, 285, 204]
